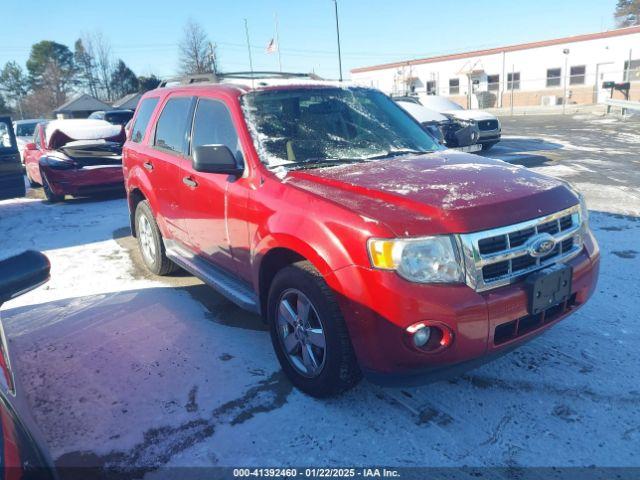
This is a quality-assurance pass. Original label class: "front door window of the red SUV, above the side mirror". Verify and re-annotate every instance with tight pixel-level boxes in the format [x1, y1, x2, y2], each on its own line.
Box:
[191, 100, 241, 160]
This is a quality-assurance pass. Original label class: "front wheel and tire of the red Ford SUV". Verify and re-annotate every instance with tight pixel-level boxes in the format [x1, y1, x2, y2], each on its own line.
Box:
[267, 262, 362, 397]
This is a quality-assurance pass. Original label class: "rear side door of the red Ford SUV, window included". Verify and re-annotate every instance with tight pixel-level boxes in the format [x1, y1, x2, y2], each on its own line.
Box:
[149, 94, 195, 243]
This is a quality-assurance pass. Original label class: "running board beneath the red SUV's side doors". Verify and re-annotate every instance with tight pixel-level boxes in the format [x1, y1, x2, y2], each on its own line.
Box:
[164, 240, 260, 314]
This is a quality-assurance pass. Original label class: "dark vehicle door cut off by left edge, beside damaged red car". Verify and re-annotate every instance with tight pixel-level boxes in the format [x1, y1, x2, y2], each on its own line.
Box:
[0, 117, 26, 200]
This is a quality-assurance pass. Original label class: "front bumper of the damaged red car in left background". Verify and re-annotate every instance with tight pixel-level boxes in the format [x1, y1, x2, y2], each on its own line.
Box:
[40, 164, 124, 195]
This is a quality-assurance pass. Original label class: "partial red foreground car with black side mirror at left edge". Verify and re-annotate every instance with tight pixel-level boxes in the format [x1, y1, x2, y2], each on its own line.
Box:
[0, 251, 57, 480]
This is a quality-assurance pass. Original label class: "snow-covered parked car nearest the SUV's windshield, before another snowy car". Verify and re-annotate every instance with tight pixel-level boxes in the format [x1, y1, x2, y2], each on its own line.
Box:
[394, 97, 482, 152]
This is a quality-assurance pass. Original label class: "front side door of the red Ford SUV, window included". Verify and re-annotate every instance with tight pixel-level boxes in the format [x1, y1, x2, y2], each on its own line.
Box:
[180, 98, 248, 273]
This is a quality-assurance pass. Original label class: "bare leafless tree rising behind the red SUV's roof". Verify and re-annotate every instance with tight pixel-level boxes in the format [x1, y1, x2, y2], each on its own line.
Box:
[179, 19, 217, 75]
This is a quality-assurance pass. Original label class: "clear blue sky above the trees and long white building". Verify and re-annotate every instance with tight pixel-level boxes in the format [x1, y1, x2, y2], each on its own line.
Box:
[0, 0, 616, 78]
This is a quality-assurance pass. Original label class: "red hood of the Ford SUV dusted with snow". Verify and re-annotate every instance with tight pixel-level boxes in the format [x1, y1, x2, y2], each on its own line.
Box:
[284, 150, 578, 236]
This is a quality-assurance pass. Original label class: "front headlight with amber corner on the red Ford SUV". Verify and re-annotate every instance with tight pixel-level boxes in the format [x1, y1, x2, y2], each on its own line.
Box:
[368, 236, 463, 283]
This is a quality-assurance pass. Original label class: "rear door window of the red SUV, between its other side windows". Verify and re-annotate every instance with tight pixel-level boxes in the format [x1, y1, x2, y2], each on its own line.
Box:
[153, 97, 192, 153]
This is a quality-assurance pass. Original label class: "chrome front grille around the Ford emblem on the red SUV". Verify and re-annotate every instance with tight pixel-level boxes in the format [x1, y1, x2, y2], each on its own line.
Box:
[460, 206, 582, 291]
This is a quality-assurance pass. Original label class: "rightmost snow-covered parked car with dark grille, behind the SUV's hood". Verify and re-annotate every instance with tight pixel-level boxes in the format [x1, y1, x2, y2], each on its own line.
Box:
[420, 95, 502, 150]
